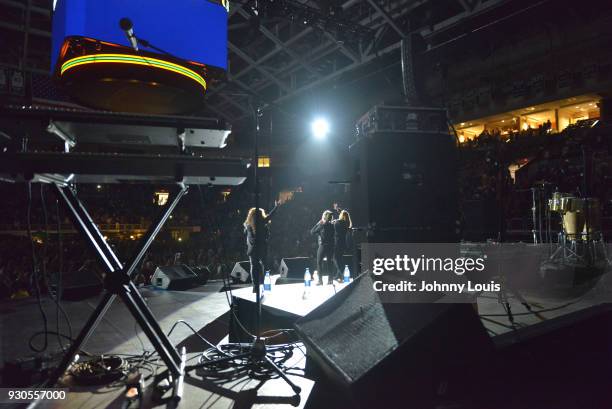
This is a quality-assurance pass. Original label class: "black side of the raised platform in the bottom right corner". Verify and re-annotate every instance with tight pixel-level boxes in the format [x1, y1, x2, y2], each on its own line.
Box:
[474, 304, 612, 409]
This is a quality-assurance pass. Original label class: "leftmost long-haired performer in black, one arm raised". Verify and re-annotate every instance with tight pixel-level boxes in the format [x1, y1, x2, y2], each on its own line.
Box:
[244, 202, 280, 292]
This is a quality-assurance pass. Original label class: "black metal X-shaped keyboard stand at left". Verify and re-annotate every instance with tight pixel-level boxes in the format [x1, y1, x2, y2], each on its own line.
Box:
[46, 183, 188, 400]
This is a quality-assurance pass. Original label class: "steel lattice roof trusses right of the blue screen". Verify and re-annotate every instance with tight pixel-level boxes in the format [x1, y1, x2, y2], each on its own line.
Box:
[207, 0, 504, 122]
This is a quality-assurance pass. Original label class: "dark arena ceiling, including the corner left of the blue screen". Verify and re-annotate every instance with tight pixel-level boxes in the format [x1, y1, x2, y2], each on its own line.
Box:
[0, 0, 517, 124]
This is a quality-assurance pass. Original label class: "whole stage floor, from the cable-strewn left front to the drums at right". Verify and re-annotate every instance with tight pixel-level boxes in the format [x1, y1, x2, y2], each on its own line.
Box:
[0, 276, 609, 408]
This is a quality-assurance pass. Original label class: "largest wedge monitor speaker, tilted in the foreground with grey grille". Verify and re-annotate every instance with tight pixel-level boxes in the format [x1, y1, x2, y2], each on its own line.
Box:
[295, 274, 493, 408]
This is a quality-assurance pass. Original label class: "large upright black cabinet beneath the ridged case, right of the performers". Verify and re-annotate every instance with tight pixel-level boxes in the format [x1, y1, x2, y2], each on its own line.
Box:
[350, 131, 458, 244]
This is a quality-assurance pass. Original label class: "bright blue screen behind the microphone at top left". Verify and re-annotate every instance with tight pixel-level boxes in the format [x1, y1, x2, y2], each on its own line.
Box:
[51, 0, 227, 70]
